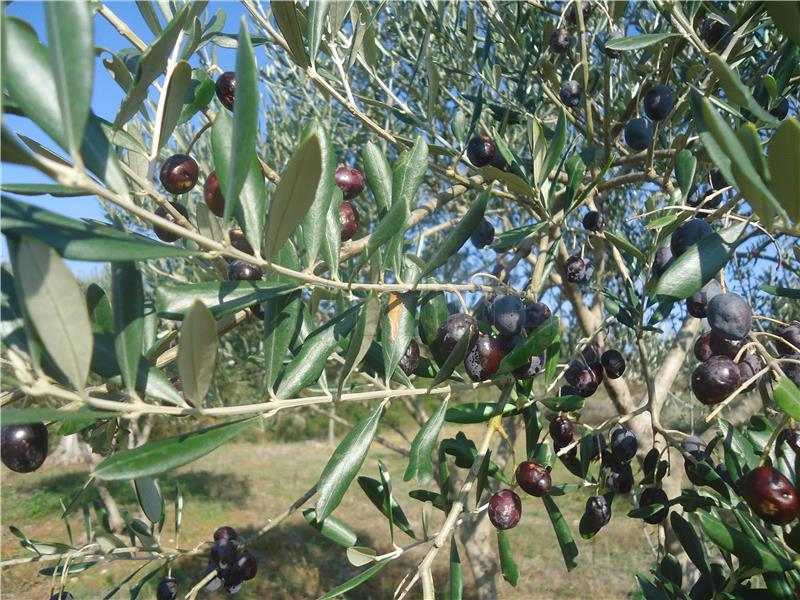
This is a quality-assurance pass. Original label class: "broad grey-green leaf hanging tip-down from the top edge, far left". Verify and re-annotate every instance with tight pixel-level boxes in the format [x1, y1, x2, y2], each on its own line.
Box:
[45, 2, 94, 156]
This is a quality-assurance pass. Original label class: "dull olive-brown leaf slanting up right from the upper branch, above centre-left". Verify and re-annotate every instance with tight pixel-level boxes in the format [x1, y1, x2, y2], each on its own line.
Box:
[264, 133, 322, 258]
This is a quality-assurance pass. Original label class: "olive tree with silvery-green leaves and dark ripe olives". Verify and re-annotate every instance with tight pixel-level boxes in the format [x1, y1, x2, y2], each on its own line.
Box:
[2, 0, 800, 598]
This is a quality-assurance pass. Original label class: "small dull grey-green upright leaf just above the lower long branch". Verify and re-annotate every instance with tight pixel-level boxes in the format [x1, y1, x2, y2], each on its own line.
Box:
[178, 300, 218, 406]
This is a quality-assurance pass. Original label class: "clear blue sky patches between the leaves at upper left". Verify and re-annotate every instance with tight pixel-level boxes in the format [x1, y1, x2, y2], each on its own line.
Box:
[0, 2, 246, 275]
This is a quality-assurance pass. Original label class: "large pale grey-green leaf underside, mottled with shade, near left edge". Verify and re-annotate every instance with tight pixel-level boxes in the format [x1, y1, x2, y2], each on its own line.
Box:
[15, 237, 93, 390]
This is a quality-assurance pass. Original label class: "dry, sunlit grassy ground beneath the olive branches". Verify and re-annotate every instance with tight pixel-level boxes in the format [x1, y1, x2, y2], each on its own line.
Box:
[2, 422, 655, 600]
